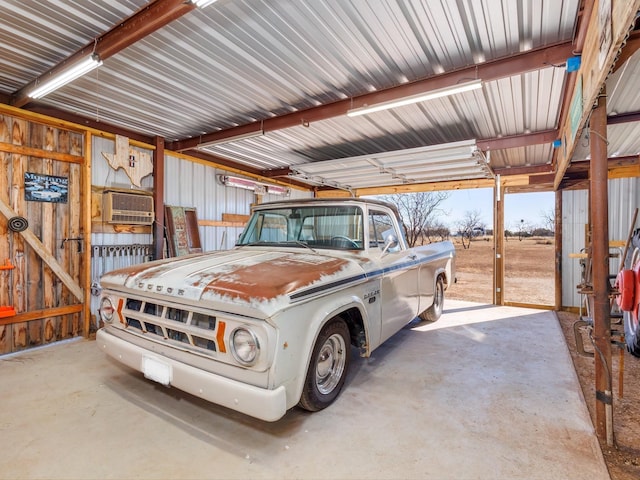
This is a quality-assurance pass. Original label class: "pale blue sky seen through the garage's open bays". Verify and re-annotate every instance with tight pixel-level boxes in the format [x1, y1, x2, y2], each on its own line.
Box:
[439, 188, 555, 230]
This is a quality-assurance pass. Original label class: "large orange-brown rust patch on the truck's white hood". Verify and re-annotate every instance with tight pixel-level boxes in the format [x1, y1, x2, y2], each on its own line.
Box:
[204, 255, 349, 302]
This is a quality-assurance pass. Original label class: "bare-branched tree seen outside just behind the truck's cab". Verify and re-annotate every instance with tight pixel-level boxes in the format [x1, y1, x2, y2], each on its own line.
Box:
[382, 192, 450, 247]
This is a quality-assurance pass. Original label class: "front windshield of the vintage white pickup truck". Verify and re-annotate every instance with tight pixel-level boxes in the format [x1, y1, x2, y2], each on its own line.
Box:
[236, 205, 364, 250]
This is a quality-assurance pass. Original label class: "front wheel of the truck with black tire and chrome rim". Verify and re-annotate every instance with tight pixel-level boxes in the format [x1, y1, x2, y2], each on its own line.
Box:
[299, 318, 351, 412]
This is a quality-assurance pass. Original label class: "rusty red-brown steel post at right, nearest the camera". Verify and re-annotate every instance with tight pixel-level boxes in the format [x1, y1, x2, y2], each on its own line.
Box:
[589, 88, 613, 445]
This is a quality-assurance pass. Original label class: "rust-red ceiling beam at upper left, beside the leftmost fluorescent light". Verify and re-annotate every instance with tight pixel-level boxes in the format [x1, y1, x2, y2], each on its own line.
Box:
[11, 0, 196, 107]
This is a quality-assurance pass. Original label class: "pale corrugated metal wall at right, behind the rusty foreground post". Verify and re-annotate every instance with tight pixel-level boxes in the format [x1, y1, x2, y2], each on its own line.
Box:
[562, 178, 640, 307]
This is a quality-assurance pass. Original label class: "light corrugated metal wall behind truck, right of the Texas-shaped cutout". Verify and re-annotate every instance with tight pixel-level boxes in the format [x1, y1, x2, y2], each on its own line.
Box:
[164, 155, 312, 252]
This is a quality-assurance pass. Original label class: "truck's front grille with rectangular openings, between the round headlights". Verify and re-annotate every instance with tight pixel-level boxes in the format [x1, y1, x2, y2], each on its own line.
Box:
[122, 298, 226, 353]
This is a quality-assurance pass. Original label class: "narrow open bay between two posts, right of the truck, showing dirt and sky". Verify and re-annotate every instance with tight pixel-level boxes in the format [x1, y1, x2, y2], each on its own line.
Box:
[504, 192, 555, 306]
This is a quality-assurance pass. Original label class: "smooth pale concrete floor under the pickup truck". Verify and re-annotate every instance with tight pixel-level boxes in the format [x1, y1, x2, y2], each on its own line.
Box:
[0, 300, 609, 480]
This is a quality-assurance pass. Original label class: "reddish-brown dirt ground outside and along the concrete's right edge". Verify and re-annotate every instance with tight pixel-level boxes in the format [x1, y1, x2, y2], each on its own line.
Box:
[445, 238, 640, 480]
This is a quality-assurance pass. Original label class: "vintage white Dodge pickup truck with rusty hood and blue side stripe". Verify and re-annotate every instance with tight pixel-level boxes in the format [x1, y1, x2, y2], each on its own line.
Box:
[97, 199, 455, 421]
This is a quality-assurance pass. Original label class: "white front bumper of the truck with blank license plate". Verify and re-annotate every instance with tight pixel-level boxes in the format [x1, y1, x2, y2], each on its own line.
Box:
[96, 329, 287, 422]
